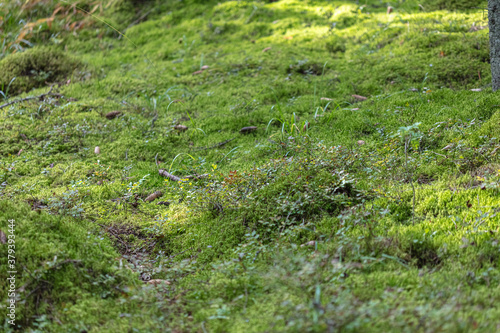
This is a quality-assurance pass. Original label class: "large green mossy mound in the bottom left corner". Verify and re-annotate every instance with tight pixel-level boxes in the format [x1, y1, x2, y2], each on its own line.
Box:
[0, 201, 138, 328]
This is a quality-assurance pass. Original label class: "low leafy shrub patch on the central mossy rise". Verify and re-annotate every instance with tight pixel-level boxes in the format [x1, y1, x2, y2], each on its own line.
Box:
[176, 144, 363, 235]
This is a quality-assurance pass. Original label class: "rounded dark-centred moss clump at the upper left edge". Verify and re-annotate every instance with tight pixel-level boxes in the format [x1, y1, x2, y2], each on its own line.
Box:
[0, 47, 80, 95]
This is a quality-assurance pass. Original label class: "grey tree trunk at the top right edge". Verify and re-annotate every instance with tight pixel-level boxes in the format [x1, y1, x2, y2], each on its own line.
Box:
[488, 0, 500, 91]
